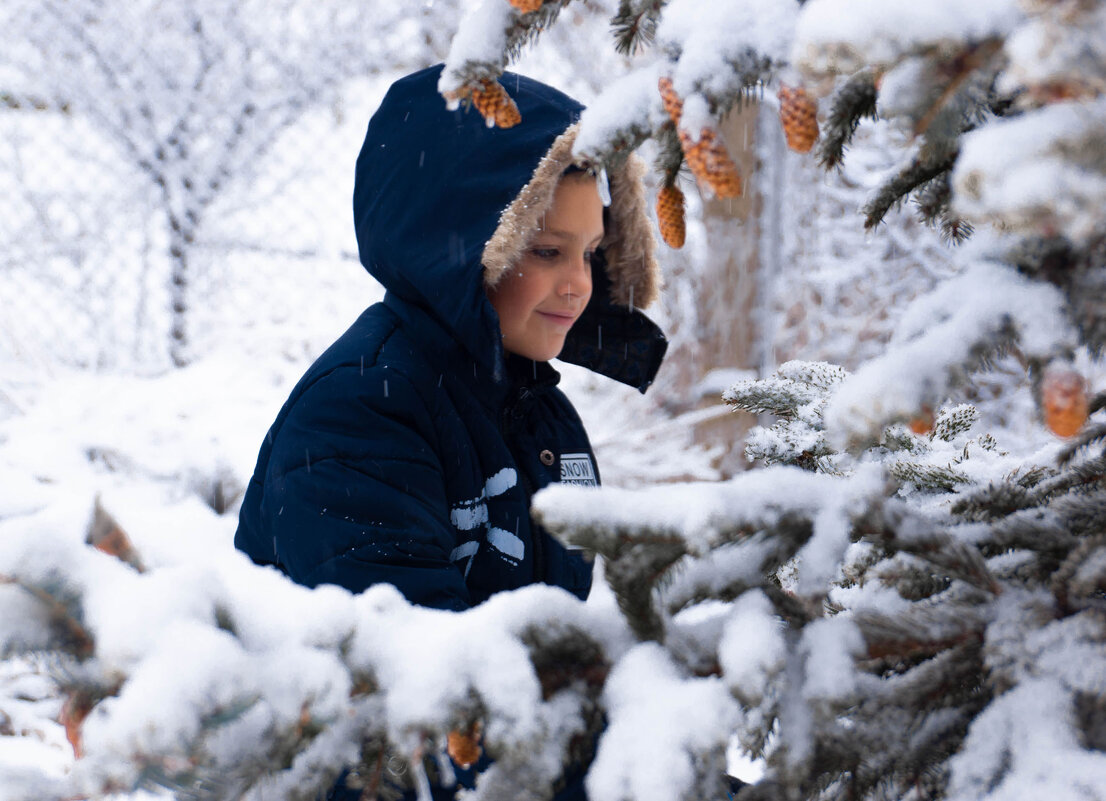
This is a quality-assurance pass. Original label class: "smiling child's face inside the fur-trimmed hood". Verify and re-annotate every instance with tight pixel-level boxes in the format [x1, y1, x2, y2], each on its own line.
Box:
[488, 178, 603, 362]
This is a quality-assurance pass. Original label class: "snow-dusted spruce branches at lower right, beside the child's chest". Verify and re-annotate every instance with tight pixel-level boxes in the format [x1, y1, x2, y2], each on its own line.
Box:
[536, 363, 1106, 801]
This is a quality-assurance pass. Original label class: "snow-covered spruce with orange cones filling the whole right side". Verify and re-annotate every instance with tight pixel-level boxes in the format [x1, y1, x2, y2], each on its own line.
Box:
[442, 0, 1106, 799]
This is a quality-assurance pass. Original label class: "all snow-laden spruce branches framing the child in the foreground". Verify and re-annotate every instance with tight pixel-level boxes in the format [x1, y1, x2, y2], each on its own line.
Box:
[0, 0, 1106, 801]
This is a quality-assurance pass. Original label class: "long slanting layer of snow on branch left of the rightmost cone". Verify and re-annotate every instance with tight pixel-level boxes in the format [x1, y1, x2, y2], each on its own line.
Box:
[825, 262, 1075, 446]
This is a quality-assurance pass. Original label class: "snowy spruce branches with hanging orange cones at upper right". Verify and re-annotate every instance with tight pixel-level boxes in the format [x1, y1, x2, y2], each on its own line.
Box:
[441, 0, 1106, 437]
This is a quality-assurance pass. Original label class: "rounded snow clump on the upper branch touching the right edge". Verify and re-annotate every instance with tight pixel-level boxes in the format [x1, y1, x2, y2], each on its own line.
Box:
[952, 97, 1106, 241]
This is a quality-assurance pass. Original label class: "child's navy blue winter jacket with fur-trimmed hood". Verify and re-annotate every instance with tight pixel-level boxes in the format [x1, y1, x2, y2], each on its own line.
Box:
[234, 67, 666, 610]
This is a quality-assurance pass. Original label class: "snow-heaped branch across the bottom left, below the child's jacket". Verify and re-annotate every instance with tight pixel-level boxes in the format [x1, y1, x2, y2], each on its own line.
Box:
[0, 506, 628, 801]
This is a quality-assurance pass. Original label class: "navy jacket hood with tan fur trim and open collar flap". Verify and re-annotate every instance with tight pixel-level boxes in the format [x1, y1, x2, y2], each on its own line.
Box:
[353, 65, 665, 392]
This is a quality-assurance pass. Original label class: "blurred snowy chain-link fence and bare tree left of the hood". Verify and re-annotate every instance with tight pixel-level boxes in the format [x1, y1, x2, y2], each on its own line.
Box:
[0, 0, 471, 371]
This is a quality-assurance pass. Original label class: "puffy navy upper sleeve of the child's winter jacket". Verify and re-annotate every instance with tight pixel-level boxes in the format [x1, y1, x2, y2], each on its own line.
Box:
[260, 367, 470, 610]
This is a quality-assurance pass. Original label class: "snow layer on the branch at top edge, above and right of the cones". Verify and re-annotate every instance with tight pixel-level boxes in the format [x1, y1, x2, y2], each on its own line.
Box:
[791, 0, 1024, 76]
